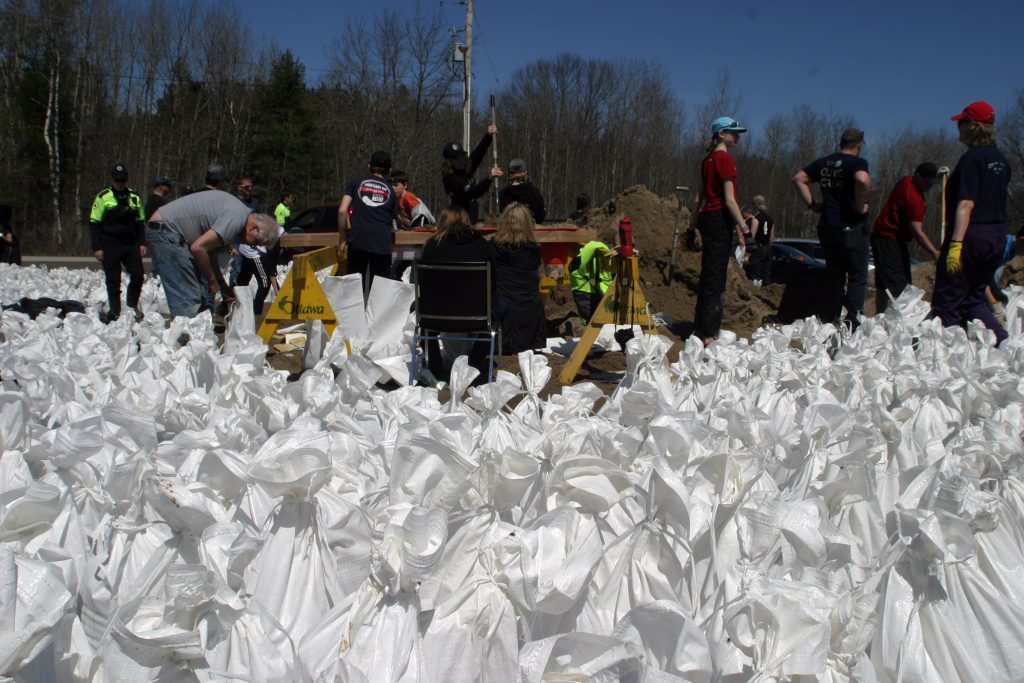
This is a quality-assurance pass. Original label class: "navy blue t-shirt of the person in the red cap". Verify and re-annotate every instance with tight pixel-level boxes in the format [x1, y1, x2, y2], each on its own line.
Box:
[946, 144, 1010, 226]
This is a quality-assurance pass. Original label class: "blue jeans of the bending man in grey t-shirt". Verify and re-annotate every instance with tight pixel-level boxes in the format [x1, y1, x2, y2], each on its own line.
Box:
[145, 222, 206, 317]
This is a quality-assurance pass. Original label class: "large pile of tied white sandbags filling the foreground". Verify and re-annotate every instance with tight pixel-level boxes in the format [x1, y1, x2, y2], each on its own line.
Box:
[0, 264, 1024, 682]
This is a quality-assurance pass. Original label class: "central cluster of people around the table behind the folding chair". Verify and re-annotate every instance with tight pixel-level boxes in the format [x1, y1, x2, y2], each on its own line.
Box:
[338, 124, 547, 376]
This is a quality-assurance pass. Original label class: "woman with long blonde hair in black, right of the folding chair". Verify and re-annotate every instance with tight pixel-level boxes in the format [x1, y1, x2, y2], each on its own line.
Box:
[495, 204, 548, 353]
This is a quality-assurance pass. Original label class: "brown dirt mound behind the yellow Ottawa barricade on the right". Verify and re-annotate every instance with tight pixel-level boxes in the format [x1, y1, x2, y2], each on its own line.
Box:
[548, 185, 783, 337]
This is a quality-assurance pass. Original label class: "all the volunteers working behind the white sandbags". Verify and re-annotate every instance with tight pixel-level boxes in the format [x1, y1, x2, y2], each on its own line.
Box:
[90, 101, 1013, 378]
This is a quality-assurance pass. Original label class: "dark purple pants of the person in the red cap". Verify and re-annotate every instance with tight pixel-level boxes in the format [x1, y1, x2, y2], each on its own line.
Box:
[930, 223, 1009, 344]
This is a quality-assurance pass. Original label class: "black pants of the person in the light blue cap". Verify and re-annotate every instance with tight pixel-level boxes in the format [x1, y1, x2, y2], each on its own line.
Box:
[693, 211, 735, 339]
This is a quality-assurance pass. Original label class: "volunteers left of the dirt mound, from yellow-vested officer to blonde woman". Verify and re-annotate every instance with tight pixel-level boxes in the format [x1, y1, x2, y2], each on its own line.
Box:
[90, 120, 547, 378]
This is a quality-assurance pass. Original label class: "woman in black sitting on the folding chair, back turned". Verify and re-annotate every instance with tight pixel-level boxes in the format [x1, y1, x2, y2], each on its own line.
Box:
[420, 206, 495, 384]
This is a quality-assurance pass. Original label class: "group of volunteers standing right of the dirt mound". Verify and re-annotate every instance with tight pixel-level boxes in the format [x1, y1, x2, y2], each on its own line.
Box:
[693, 101, 1014, 345]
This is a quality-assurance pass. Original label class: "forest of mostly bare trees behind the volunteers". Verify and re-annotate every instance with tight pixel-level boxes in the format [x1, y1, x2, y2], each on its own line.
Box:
[0, 0, 1024, 255]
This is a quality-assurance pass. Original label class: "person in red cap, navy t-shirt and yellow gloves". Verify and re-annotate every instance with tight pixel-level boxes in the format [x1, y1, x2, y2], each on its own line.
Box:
[930, 101, 1010, 345]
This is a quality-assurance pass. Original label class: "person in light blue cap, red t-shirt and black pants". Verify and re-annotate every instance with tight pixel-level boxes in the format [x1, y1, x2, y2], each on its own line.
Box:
[693, 116, 746, 346]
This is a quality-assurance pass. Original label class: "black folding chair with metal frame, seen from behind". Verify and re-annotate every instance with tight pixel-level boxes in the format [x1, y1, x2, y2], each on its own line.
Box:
[409, 261, 501, 384]
